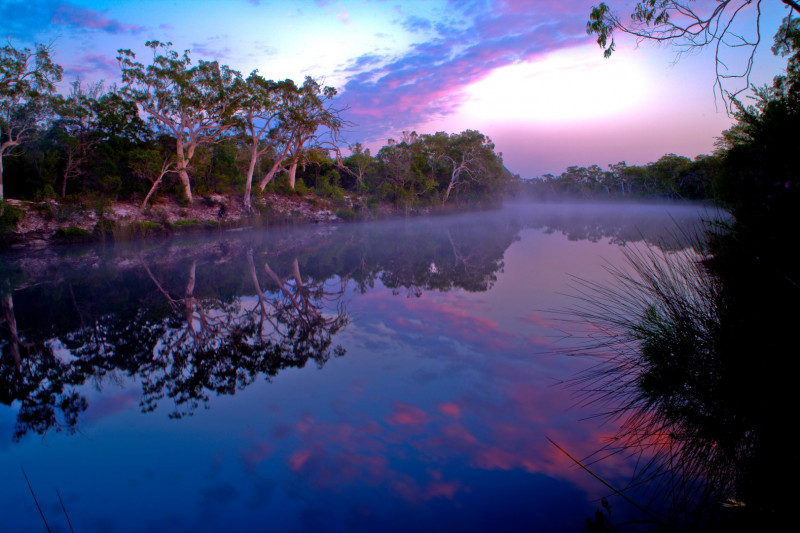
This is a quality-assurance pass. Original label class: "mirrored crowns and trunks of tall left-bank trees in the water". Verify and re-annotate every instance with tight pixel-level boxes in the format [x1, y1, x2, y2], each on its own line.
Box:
[0, 245, 349, 440]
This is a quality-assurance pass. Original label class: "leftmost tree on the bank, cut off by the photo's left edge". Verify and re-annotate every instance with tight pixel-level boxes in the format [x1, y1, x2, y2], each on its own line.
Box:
[0, 43, 63, 201]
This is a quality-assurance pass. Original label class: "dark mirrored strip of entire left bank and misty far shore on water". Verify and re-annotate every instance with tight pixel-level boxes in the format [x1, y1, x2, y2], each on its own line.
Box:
[0, 205, 708, 439]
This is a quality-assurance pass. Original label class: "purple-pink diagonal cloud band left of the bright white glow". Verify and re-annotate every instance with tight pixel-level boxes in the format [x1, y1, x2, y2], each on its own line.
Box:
[340, 0, 587, 142]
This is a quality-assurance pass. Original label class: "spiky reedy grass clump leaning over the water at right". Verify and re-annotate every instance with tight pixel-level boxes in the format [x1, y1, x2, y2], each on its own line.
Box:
[569, 223, 758, 523]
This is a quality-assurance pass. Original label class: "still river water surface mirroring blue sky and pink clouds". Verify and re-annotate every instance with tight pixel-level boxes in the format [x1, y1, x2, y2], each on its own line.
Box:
[0, 204, 708, 531]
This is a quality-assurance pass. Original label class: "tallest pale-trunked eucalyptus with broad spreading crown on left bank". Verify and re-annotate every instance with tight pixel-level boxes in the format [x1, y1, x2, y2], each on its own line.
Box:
[117, 41, 243, 203]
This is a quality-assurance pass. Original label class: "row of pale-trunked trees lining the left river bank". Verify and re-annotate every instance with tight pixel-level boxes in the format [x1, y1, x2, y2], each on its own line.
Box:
[0, 41, 516, 218]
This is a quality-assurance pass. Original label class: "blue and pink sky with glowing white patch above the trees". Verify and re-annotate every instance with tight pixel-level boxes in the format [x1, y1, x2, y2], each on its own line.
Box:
[0, 0, 786, 178]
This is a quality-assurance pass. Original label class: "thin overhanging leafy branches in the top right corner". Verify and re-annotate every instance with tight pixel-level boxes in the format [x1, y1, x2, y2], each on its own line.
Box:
[586, 0, 800, 110]
